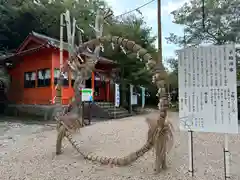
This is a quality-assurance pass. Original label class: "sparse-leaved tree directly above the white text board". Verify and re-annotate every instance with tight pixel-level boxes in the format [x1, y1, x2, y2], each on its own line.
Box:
[166, 0, 240, 46]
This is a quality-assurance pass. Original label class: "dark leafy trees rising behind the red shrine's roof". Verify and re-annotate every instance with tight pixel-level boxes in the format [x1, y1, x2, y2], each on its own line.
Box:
[0, 0, 106, 51]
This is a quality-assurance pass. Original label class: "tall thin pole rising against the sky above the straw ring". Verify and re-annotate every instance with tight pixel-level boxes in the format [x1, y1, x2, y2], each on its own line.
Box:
[157, 0, 162, 62]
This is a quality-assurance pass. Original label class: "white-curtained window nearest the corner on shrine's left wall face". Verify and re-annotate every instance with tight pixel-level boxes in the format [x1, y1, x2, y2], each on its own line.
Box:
[37, 69, 51, 87]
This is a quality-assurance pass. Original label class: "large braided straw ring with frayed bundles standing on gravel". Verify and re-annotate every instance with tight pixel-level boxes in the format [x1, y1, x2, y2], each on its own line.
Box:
[55, 8, 173, 173]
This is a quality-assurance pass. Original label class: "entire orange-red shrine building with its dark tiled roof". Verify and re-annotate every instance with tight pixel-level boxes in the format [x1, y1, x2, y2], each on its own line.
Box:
[5, 32, 119, 105]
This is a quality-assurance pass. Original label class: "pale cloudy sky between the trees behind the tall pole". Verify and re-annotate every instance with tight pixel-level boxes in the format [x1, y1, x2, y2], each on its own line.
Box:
[107, 0, 189, 61]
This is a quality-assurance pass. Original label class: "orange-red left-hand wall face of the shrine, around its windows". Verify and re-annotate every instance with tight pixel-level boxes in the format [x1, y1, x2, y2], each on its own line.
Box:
[8, 49, 52, 104]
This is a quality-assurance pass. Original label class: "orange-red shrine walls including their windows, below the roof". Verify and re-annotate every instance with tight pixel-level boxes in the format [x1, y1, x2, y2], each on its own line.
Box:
[8, 48, 114, 104]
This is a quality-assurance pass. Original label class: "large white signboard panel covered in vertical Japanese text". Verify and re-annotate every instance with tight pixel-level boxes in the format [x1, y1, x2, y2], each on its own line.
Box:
[178, 45, 238, 133]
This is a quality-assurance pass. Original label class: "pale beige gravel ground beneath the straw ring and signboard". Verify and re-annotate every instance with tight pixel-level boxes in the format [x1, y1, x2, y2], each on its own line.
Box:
[0, 113, 240, 180]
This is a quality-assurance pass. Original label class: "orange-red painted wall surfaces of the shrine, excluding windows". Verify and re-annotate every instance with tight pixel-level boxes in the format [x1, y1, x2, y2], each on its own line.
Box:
[8, 48, 114, 104]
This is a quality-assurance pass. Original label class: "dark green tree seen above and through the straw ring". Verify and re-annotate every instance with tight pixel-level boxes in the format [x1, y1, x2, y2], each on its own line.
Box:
[106, 15, 156, 84]
